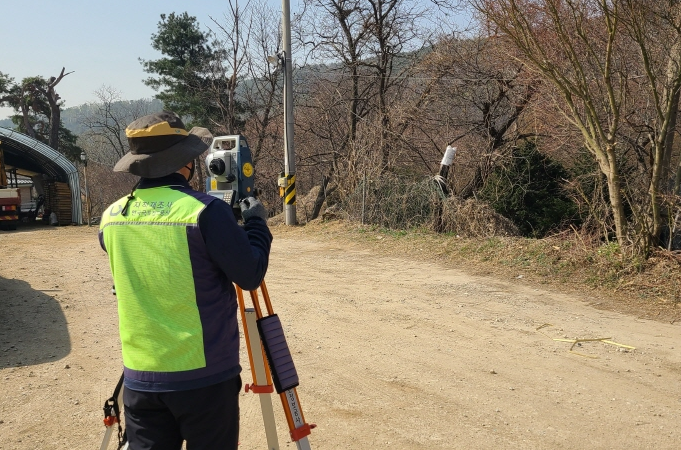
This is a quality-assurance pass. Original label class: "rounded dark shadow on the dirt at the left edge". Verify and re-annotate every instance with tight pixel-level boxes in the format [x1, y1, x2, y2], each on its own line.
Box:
[0, 277, 71, 369]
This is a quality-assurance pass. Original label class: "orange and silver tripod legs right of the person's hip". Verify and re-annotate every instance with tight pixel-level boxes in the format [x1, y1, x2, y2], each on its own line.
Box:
[236, 281, 315, 450]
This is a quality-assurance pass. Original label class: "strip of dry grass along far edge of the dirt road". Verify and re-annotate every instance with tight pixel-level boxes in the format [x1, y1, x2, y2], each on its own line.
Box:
[269, 183, 681, 322]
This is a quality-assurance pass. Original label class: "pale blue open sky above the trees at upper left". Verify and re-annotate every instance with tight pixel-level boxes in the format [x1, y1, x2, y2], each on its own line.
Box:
[0, 0, 298, 119]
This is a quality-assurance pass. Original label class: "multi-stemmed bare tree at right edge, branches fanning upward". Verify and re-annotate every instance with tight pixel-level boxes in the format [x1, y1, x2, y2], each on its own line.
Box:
[472, 0, 681, 250]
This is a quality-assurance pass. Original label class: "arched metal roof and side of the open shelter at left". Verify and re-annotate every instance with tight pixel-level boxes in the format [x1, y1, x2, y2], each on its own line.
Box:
[0, 127, 83, 224]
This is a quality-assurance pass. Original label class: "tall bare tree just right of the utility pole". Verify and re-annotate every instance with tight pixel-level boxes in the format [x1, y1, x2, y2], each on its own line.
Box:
[296, 0, 452, 215]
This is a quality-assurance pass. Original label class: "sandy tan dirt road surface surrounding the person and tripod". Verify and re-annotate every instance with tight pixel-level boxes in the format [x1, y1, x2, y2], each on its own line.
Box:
[0, 227, 681, 450]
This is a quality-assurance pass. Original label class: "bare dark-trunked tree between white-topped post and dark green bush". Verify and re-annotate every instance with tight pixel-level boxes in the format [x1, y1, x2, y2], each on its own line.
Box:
[399, 36, 540, 198]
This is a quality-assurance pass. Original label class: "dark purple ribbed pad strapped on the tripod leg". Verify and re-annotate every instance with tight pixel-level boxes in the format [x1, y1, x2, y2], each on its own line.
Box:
[257, 314, 299, 394]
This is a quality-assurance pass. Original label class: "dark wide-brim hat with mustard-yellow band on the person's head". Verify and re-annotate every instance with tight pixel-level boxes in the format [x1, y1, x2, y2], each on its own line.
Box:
[114, 111, 213, 178]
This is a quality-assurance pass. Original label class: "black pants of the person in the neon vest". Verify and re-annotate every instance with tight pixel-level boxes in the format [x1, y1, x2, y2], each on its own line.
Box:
[123, 375, 241, 450]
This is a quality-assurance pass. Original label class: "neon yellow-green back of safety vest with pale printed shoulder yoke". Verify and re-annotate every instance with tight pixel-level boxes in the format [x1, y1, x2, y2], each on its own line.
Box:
[100, 186, 206, 372]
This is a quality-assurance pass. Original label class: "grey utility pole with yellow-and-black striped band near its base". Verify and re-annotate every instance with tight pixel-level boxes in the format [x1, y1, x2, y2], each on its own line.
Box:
[281, 0, 296, 225]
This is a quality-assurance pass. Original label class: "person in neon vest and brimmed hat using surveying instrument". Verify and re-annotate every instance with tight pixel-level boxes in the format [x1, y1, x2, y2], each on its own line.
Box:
[100, 112, 272, 450]
